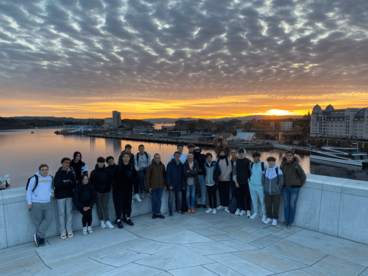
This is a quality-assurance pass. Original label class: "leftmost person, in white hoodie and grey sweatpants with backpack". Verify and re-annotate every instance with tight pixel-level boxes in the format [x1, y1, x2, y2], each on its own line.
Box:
[26, 164, 54, 247]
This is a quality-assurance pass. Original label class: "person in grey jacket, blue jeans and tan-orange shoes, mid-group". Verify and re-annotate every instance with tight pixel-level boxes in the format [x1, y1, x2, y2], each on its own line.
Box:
[183, 153, 202, 213]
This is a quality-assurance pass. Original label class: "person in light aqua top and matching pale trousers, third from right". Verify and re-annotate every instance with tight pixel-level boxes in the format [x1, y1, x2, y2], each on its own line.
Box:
[249, 152, 267, 221]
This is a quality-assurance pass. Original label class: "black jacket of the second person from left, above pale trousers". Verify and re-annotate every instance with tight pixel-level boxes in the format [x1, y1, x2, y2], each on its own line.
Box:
[54, 167, 77, 199]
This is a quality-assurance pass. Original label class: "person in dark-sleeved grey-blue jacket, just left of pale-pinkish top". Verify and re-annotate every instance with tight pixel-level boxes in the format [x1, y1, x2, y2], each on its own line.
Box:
[203, 153, 221, 215]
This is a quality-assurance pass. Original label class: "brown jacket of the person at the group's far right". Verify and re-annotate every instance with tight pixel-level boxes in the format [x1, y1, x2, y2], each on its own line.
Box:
[280, 156, 307, 188]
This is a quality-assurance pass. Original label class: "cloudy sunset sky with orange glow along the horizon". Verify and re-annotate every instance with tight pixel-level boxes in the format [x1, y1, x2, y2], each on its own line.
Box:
[0, 0, 368, 118]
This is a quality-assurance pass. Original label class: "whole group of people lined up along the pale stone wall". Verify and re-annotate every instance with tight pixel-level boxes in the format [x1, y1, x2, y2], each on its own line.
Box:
[27, 136, 306, 246]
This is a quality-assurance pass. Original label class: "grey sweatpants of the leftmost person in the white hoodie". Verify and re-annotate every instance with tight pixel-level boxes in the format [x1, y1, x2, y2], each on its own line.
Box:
[30, 202, 54, 239]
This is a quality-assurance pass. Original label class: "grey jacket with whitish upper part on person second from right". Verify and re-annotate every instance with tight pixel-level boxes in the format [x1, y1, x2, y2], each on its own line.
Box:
[262, 164, 284, 195]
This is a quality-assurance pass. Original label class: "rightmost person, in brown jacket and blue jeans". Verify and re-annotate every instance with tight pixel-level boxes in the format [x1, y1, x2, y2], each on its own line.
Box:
[280, 150, 307, 229]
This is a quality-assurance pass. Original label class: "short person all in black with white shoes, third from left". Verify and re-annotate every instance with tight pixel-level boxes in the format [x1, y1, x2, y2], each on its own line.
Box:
[73, 175, 97, 235]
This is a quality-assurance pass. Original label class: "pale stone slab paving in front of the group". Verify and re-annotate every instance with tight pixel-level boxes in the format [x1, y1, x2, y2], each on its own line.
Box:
[0, 209, 368, 276]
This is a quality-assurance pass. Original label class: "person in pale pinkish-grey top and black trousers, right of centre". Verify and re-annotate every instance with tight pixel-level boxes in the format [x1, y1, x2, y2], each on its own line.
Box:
[217, 149, 232, 213]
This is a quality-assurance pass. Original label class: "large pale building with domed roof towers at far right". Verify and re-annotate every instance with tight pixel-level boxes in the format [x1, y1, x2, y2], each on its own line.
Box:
[310, 104, 368, 139]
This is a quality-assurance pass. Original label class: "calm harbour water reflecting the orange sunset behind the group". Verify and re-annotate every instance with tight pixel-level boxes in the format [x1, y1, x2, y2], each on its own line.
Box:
[0, 129, 368, 188]
